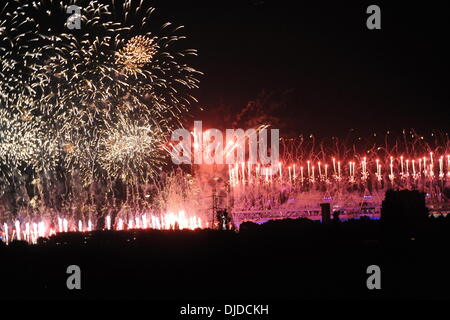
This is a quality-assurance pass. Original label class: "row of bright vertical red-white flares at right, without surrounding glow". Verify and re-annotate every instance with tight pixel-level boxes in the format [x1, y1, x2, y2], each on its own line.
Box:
[228, 152, 450, 188]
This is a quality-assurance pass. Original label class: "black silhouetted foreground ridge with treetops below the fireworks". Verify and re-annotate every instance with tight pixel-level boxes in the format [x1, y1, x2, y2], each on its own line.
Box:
[0, 193, 450, 300]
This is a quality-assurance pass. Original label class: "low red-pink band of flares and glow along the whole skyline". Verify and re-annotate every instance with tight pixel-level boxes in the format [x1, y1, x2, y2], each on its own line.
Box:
[0, 133, 450, 243]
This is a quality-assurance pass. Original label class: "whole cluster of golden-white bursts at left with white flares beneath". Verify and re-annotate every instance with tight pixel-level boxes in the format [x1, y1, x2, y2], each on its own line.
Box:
[0, 0, 200, 240]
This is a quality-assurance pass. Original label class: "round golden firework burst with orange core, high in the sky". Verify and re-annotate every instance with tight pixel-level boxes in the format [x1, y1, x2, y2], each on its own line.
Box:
[37, 1, 199, 123]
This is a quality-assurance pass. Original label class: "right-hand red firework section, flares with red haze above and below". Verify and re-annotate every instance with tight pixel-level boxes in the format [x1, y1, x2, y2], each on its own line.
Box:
[227, 131, 450, 221]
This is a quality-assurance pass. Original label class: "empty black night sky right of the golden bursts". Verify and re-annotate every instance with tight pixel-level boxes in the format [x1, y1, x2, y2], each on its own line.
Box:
[152, 0, 450, 136]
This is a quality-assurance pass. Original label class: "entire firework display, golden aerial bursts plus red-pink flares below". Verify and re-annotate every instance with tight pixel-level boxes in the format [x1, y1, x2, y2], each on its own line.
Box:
[0, 0, 450, 243]
